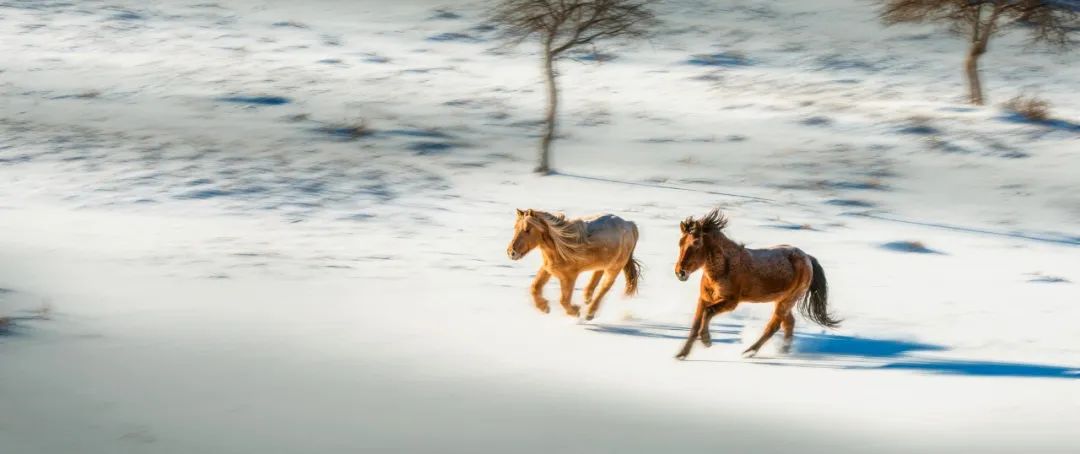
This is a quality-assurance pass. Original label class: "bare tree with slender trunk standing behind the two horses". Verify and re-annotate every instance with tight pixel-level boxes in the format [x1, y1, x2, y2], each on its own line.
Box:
[490, 0, 657, 173]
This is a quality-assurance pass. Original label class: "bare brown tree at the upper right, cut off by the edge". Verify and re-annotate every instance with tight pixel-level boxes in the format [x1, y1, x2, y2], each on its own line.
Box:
[881, 0, 1080, 105]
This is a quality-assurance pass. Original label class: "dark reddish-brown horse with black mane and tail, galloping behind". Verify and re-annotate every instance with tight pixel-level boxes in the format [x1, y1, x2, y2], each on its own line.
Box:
[675, 210, 839, 359]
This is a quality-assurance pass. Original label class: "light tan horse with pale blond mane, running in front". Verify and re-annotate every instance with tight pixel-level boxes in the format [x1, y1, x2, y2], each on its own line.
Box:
[507, 210, 642, 320]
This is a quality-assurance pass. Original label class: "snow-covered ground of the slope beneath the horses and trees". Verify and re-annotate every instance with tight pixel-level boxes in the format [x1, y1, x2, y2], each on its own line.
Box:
[0, 0, 1080, 454]
